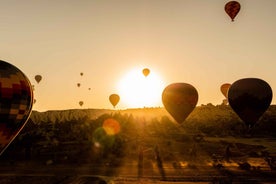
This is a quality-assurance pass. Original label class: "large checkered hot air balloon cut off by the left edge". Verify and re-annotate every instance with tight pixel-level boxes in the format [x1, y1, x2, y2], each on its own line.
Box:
[0, 60, 33, 155]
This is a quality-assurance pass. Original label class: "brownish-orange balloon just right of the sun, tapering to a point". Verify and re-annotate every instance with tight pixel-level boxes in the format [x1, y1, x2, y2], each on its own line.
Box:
[162, 83, 198, 124]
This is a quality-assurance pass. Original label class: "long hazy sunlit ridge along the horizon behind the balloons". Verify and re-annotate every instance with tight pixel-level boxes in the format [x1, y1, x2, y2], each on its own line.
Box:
[30, 104, 276, 135]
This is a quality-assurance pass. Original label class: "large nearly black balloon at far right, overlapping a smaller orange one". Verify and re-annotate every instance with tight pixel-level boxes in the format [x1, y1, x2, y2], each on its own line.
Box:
[228, 78, 272, 127]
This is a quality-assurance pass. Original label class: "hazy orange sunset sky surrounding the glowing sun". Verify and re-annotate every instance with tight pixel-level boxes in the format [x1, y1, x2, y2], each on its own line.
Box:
[0, 0, 276, 111]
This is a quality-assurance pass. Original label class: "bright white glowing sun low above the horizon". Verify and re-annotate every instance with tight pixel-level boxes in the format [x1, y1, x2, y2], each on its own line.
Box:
[118, 68, 165, 108]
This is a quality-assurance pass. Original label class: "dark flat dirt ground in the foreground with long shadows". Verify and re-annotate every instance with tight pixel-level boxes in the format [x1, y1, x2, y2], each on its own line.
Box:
[0, 137, 276, 184]
